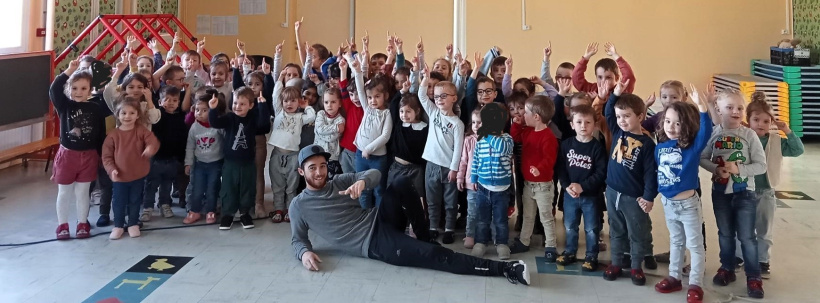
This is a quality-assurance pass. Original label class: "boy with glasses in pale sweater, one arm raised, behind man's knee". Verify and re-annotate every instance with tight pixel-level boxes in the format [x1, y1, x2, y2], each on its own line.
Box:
[418, 69, 464, 243]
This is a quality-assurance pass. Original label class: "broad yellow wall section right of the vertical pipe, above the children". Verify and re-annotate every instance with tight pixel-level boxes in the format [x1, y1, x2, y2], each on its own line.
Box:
[466, 0, 786, 96]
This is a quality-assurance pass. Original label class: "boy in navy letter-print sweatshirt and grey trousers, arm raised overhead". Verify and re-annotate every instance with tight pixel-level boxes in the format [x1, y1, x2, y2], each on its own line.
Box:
[604, 80, 658, 285]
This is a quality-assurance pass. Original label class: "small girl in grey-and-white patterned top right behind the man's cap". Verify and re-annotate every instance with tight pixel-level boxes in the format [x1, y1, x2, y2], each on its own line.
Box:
[314, 87, 345, 180]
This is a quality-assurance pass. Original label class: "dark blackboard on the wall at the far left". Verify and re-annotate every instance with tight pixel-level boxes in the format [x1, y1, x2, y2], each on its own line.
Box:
[0, 52, 54, 128]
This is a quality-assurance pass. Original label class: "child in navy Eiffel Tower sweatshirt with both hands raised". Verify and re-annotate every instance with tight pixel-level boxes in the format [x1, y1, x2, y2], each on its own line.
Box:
[208, 87, 270, 230]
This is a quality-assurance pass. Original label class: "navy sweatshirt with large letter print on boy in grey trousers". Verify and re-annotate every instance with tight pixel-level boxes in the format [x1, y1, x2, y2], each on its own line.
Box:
[605, 93, 658, 201]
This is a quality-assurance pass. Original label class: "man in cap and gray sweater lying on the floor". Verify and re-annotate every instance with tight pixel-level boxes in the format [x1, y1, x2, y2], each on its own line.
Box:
[288, 145, 530, 285]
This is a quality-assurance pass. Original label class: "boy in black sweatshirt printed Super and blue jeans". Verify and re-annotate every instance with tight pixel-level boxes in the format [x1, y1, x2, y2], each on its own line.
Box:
[556, 104, 607, 271]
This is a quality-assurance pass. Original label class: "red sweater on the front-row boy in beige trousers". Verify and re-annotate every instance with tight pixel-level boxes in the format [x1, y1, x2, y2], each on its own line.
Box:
[510, 123, 558, 182]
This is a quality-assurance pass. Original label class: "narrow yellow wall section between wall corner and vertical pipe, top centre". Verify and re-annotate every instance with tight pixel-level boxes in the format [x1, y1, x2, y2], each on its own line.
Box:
[356, 0, 453, 61]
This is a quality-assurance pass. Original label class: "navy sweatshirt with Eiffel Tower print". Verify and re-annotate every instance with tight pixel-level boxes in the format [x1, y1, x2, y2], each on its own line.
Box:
[208, 102, 270, 162]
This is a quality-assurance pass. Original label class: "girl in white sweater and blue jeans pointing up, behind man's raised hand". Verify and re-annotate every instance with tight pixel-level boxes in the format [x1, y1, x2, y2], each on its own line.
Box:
[348, 58, 393, 208]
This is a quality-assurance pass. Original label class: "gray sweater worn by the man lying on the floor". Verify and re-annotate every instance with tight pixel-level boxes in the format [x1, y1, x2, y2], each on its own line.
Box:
[288, 169, 381, 260]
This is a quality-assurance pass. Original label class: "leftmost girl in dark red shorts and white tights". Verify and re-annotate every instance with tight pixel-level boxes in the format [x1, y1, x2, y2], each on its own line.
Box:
[49, 60, 110, 240]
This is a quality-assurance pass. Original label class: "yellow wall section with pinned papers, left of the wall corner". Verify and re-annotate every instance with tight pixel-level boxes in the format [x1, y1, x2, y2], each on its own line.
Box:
[180, 0, 350, 62]
